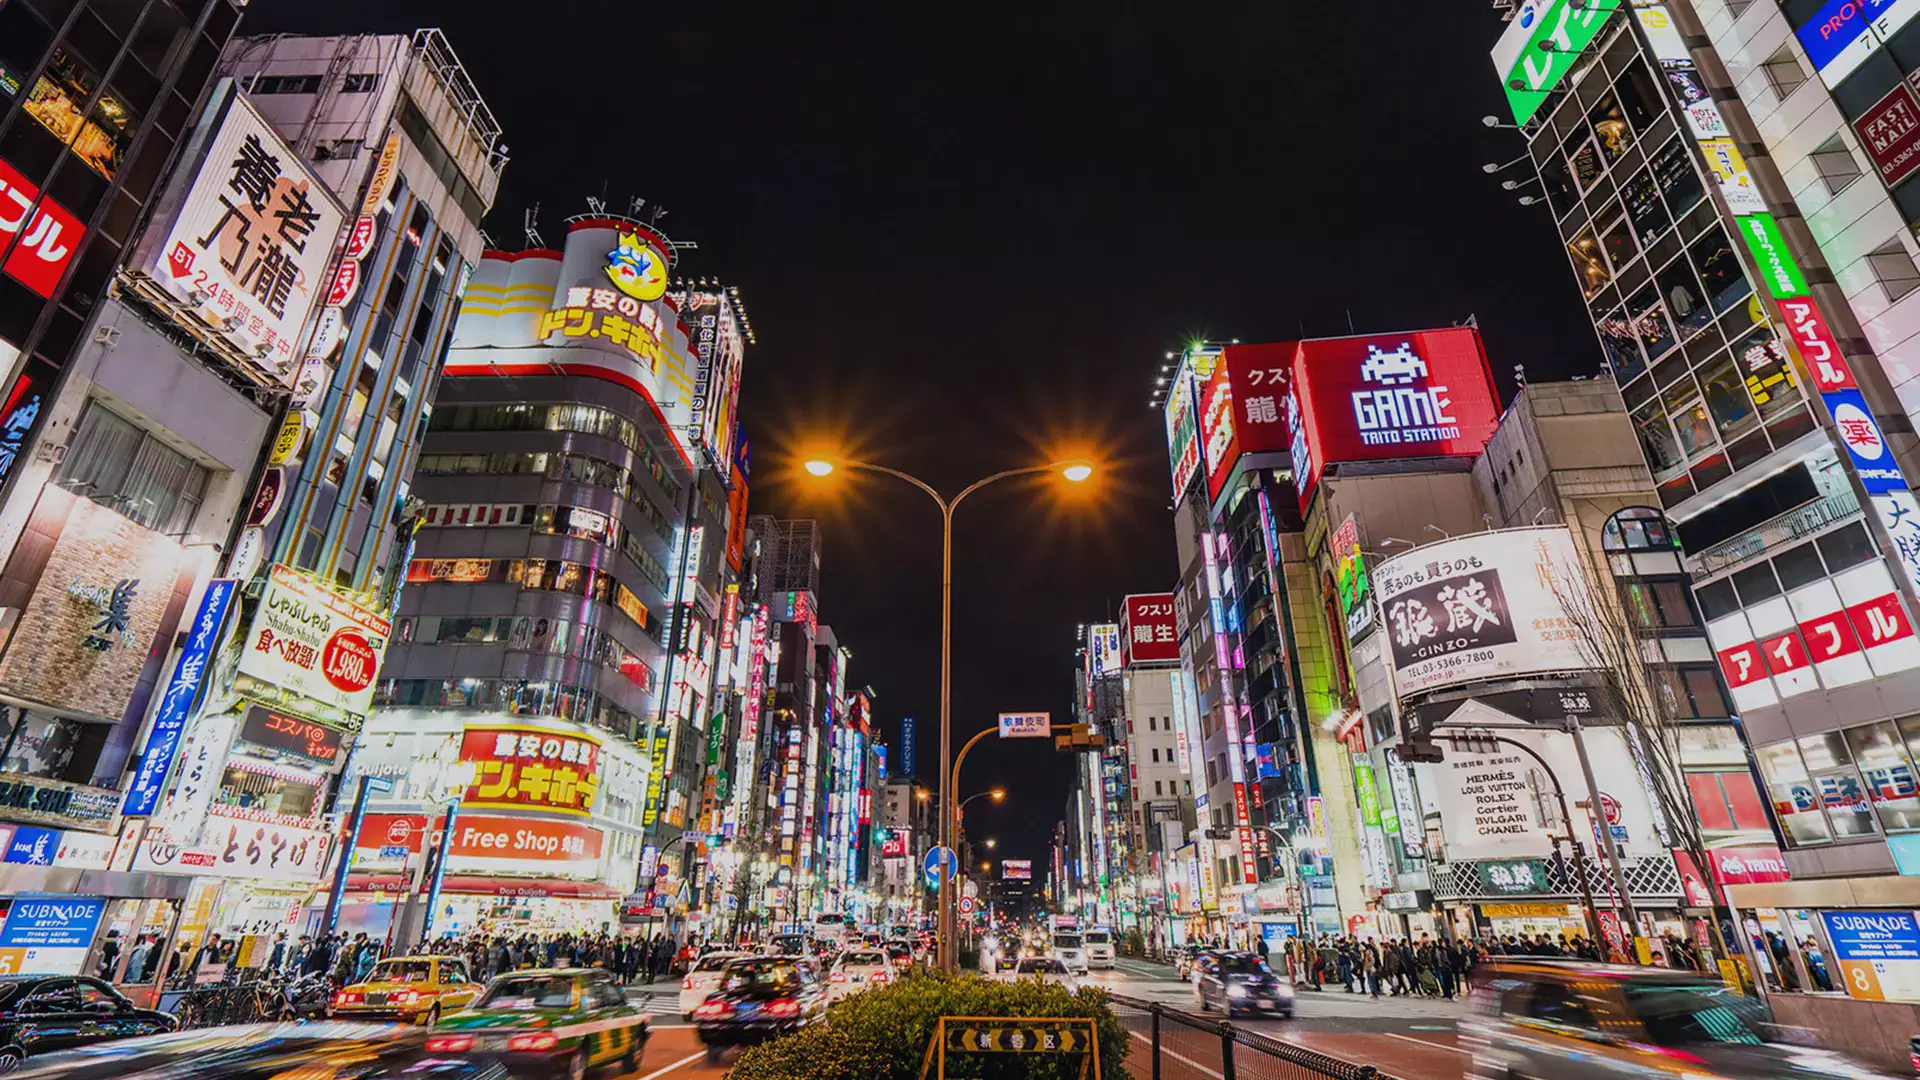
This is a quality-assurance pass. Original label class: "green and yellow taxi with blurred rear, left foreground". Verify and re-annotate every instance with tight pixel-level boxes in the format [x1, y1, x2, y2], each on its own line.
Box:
[426, 969, 653, 1080]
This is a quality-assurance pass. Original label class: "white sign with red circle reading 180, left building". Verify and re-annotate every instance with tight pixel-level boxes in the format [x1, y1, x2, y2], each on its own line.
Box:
[240, 565, 392, 715]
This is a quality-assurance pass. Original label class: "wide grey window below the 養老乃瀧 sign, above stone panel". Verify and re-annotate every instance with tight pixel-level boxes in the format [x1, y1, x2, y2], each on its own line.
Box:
[54, 402, 207, 536]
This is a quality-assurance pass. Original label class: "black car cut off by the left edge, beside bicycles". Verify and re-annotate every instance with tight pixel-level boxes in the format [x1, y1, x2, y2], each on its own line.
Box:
[0, 974, 179, 1072]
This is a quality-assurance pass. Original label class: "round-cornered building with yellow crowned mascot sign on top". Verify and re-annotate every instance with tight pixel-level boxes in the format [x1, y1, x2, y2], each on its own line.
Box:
[349, 203, 741, 930]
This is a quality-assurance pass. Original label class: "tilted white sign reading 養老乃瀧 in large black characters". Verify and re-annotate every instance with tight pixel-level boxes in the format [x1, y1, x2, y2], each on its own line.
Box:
[144, 81, 346, 386]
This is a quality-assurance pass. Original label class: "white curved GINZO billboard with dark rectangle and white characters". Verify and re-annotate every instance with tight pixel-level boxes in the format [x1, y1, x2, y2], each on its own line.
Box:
[1375, 525, 1594, 696]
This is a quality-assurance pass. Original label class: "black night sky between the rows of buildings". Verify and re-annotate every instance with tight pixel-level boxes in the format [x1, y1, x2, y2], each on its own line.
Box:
[242, 0, 1599, 871]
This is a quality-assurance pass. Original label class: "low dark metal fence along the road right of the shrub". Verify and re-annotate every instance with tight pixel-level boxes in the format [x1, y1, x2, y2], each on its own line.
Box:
[1108, 994, 1396, 1080]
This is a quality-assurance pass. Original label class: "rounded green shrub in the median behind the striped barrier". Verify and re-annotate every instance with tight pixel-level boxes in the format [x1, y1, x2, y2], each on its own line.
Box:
[732, 974, 1129, 1080]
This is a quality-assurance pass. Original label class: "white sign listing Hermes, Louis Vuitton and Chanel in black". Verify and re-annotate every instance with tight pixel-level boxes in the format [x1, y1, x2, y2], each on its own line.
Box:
[1419, 701, 1665, 863]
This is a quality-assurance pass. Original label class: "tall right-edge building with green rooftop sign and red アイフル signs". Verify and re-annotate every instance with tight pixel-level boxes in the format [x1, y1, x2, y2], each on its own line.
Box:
[1492, 0, 1920, 1063]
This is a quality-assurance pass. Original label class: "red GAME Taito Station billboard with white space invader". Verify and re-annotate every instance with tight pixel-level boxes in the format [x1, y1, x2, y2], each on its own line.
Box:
[1282, 327, 1500, 511]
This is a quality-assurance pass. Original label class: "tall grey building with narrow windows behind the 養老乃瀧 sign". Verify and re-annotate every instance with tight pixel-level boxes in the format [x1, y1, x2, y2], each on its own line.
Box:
[221, 29, 507, 595]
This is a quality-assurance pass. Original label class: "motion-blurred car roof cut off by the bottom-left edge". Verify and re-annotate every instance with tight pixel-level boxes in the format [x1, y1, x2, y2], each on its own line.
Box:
[10, 1020, 505, 1080]
